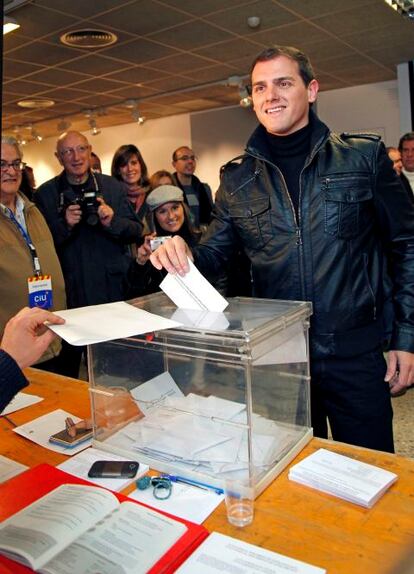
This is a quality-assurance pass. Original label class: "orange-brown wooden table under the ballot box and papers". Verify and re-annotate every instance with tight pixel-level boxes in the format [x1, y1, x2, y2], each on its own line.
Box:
[0, 369, 414, 574]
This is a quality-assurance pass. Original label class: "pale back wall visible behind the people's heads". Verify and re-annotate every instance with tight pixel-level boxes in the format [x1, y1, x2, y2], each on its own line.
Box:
[24, 81, 400, 192]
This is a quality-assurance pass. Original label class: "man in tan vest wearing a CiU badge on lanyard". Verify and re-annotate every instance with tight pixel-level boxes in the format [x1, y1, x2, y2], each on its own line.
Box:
[0, 136, 66, 371]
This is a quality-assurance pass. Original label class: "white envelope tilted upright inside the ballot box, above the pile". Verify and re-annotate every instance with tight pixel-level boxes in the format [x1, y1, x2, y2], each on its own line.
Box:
[130, 371, 184, 415]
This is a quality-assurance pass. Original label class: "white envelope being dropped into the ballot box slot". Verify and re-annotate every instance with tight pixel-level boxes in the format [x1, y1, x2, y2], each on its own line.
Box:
[160, 259, 228, 312]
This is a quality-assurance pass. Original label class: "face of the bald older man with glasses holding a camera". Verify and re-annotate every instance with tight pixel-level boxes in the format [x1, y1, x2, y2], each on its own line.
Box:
[56, 132, 91, 180]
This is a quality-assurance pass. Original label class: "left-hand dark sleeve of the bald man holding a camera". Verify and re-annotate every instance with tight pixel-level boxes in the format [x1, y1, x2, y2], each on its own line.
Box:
[34, 184, 76, 246]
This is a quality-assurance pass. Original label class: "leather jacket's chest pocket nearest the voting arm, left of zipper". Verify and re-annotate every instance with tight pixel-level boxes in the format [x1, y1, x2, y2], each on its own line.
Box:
[229, 197, 272, 250]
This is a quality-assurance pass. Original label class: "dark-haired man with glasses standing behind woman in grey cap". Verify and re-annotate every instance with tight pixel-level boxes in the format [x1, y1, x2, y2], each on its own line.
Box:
[172, 146, 213, 228]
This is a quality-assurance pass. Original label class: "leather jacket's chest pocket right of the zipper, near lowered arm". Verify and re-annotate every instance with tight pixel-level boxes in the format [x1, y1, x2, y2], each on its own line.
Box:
[324, 176, 372, 239]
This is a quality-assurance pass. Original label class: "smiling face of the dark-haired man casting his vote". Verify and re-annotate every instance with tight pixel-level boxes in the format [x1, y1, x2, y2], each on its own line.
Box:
[252, 56, 319, 136]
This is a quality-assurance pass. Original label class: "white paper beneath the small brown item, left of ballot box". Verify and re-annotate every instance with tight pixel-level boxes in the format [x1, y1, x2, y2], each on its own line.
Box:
[13, 409, 92, 456]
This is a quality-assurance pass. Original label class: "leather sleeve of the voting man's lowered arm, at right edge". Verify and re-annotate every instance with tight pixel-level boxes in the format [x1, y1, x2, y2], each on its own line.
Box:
[375, 144, 414, 352]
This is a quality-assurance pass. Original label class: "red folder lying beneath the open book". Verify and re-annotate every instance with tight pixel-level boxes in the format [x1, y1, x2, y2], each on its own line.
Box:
[0, 464, 208, 574]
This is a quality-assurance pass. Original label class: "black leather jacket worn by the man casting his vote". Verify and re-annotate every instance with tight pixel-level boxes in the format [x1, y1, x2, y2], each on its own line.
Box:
[195, 112, 414, 357]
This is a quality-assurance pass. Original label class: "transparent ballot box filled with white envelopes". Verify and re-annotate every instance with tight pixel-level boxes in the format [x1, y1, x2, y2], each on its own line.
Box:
[88, 293, 312, 494]
